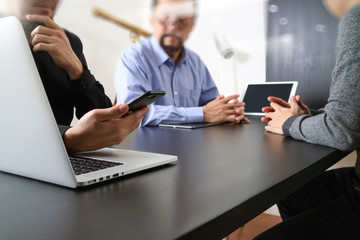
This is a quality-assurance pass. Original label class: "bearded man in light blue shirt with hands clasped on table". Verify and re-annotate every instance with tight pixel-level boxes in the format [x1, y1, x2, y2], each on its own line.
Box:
[115, 0, 249, 126]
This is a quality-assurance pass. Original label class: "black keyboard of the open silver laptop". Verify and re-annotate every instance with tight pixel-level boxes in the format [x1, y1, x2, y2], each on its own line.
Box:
[70, 157, 123, 175]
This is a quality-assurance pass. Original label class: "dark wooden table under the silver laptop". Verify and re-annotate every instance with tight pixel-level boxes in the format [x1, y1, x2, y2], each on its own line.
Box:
[0, 119, 347, 240]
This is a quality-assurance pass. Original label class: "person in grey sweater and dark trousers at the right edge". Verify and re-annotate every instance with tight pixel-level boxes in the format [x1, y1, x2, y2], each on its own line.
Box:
[255, 0, 360, 240]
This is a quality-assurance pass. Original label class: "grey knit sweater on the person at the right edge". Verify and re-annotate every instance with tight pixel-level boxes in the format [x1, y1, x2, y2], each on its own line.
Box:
[283, 5, 360, 177]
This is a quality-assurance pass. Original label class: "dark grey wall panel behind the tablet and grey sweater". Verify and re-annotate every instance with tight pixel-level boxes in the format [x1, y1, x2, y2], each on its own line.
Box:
[266, 0, 338, 108]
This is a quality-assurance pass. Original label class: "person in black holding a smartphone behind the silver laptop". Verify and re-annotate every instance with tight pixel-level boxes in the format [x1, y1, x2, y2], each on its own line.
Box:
[0, 0, 148, 152]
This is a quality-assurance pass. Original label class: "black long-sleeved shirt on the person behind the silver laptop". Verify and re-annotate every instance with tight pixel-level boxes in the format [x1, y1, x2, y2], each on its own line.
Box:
[33, 30, 112, 126]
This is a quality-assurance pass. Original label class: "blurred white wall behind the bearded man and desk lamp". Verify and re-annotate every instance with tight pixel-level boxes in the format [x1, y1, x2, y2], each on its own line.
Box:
[55, 0, 267, 102]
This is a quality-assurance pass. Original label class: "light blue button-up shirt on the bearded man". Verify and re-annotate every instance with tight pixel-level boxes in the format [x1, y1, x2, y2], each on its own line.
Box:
[114, 37, 219, 126]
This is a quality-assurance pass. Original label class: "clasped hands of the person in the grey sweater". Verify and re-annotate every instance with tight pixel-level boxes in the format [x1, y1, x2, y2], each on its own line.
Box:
[261, 95, 310, 134]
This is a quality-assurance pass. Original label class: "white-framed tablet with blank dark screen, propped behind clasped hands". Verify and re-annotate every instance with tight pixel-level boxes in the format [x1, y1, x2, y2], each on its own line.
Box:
[242, 81, 298, 116]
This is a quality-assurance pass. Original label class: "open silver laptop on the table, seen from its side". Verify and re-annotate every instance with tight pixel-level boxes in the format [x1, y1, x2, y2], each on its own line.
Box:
[0, 17, 177, 188]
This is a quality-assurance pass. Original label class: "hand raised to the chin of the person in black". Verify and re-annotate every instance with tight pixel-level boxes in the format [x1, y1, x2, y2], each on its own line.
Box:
[26, 15, 84, 80]
